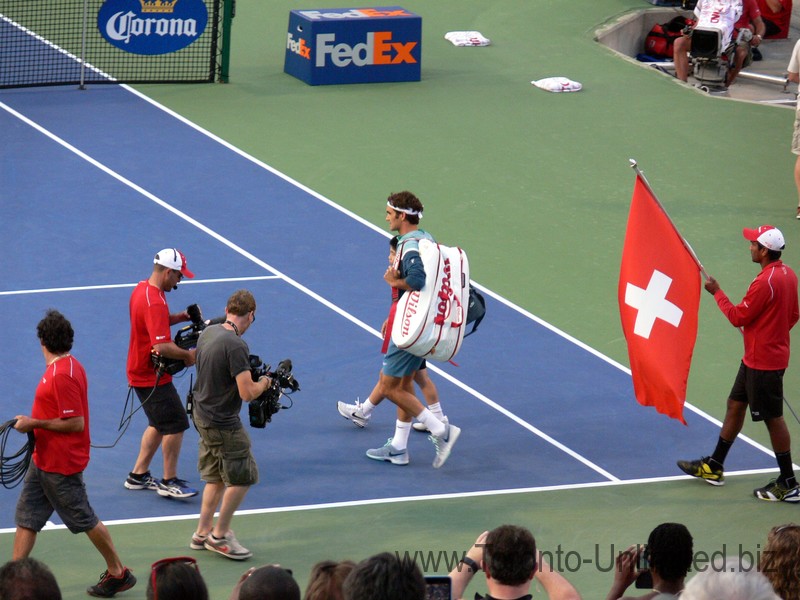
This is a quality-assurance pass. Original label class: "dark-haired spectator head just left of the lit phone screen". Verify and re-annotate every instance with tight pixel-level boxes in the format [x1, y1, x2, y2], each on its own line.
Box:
[343, 552, 425, 600]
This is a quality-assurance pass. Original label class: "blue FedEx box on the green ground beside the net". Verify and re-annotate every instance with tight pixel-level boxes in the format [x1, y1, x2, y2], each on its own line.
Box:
[284, 6, 422, 85]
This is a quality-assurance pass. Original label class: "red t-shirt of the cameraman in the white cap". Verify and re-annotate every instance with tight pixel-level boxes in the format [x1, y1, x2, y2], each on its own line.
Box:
[127, 281, 172, 387]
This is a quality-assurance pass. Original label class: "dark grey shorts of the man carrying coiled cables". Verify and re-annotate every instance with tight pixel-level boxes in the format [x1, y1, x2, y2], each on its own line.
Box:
[14, 463, 100, 533]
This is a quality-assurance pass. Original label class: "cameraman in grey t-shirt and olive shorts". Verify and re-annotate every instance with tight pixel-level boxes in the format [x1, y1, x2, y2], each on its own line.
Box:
[189, 290, 272, 560]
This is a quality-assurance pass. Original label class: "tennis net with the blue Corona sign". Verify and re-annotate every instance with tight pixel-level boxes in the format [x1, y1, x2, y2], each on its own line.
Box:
[0, 0, 233, 88]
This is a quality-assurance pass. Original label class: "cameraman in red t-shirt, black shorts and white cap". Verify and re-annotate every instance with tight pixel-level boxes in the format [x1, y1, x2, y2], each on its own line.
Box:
[125, 248, 197, 498]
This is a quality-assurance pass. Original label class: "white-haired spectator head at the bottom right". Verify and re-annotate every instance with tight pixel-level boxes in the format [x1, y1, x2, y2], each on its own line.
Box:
[681, 561, 780, 600]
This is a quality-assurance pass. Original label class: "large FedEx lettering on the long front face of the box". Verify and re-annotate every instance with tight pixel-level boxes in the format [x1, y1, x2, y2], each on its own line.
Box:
[315, 31, 417, 67]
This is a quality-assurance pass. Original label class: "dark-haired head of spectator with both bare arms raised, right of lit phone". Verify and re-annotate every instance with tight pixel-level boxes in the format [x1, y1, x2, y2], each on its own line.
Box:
[483, 525, 536, 586]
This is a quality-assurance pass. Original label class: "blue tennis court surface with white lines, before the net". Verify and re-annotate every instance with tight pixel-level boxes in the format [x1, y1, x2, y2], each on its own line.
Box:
[0, 86, 774, 528]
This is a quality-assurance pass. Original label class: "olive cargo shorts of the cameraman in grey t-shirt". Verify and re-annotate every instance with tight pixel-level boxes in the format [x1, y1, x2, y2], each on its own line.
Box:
[195, 423, 258, 486]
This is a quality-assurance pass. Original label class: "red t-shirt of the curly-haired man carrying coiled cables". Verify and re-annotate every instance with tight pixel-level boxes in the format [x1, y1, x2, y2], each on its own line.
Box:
[31, 356, 91, 475]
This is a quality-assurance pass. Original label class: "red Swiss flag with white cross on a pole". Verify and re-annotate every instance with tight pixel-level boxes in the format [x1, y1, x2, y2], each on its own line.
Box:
[618, 174, 700, 425]
